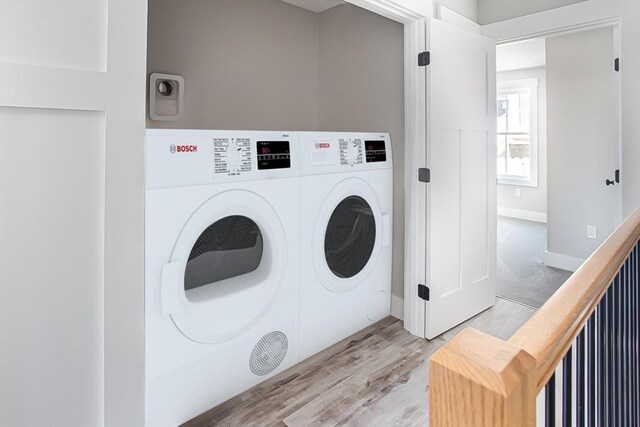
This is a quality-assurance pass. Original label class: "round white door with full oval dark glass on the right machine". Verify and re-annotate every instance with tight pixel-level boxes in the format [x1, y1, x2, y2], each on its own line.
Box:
[313, 178, 383, 292]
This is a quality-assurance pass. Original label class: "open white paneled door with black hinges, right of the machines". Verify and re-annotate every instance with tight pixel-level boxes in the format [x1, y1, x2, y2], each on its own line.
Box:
[424, 20, 496, 339]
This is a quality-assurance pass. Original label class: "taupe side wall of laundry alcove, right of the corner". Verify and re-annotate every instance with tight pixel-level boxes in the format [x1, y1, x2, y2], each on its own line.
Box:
[318, 5, 404, 297]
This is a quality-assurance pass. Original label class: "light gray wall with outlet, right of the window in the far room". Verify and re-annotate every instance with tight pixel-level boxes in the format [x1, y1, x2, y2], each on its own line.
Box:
[546, 27, 619, 260]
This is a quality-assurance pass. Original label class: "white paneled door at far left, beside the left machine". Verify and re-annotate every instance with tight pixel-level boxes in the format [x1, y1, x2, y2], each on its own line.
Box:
[0, 0, 147, 426]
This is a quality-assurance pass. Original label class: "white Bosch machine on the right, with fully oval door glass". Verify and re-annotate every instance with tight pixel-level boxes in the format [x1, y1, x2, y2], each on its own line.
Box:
[298, 132, 393, 360]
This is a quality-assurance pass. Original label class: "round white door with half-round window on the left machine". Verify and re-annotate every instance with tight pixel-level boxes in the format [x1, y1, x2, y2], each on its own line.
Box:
[161, 190, 287, 344]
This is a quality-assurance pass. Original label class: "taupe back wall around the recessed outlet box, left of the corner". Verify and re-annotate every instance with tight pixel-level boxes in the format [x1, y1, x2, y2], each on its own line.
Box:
[147, 0, 318, 130]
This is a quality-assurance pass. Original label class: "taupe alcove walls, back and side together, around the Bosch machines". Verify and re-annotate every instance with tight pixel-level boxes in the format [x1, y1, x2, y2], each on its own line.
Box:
[147, 0, 404, 298]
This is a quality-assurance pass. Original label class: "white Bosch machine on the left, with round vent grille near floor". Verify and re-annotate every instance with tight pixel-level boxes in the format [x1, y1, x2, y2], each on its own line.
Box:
[145, 130, 300, 426]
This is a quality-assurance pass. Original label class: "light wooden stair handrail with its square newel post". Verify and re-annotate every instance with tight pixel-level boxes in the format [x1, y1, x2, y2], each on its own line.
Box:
[429, 208, 640, 427]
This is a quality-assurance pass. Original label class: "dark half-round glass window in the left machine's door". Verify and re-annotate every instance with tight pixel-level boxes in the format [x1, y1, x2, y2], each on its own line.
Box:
[184, 215, 262, 291]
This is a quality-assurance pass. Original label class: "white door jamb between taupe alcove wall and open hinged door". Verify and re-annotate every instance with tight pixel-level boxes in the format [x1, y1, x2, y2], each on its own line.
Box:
[346, 0, 433, 337]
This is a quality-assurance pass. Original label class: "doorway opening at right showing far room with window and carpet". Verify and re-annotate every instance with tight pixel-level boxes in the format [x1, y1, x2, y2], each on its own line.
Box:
[496, 25, 621, 308]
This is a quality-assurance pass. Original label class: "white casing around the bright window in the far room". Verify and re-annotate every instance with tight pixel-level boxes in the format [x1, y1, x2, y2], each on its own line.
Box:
[497, 67, 547, 218]
